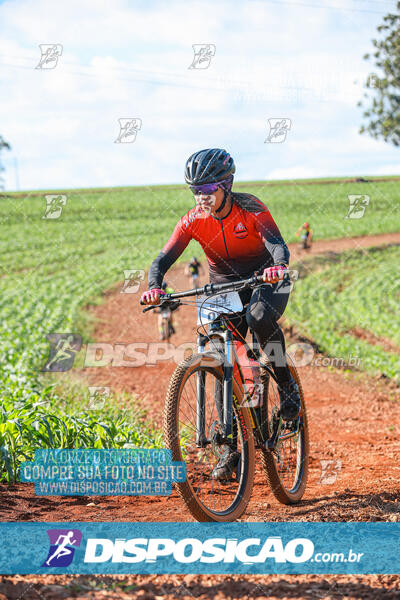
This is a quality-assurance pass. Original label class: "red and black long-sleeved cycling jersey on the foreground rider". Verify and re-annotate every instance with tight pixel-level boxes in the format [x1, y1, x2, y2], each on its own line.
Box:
[149, 192, 289, 289]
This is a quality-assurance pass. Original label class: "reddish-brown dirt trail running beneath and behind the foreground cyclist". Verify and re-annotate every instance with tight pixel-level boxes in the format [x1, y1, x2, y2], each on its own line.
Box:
[0, 233, 400, 599]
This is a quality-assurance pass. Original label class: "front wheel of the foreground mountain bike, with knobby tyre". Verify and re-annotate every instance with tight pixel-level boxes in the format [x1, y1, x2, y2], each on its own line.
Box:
[164, 353, 255, 521]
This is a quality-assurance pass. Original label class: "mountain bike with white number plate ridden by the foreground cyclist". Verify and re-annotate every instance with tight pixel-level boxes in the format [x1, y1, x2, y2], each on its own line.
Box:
[144, 276, 309, 521]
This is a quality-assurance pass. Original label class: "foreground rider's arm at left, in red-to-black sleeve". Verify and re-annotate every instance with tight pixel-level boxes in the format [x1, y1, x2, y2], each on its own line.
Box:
[149, 219, 192, 290]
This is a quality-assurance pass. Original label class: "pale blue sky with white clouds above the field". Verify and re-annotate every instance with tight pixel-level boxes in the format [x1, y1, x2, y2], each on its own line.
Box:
[0, 0, 400, 190]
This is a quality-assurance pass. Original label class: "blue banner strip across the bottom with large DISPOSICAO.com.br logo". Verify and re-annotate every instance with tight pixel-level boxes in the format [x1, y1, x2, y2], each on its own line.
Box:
[0, 522, 400, 575]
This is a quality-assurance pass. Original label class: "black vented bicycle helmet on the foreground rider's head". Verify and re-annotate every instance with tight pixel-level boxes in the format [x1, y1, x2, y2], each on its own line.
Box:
[185, 148, 236, 185]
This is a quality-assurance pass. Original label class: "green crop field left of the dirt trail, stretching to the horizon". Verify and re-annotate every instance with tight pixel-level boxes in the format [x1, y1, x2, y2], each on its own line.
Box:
[0, 180, 400, 479]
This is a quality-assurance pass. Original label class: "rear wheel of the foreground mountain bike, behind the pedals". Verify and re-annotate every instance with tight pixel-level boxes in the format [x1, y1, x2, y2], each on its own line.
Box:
[261, 365, 309, 504]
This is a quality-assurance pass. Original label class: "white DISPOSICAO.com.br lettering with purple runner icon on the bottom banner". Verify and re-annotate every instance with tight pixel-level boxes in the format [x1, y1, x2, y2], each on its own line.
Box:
[42, 529, 363, 572]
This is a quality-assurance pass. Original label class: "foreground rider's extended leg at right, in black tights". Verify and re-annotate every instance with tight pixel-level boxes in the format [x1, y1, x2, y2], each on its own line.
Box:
[246, 282, 300, 420]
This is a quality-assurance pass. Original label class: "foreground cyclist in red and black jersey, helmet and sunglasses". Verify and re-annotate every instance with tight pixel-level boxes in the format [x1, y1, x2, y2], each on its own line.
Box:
[141, 148, 300, 479]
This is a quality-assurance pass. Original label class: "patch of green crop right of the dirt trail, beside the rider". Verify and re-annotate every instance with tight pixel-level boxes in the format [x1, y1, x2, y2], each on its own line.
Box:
[285, 246, 400, 380]
